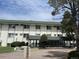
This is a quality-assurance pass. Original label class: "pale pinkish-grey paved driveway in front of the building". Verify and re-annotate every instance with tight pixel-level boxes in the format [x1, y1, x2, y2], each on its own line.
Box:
[0, 48, 73, 59]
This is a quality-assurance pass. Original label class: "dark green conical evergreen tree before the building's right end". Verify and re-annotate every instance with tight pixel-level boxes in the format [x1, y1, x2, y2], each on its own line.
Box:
[61, 11, 75, 47]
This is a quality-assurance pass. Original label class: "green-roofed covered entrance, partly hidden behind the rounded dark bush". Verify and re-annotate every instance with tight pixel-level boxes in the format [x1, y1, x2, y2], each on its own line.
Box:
[29, 36, 64, 48]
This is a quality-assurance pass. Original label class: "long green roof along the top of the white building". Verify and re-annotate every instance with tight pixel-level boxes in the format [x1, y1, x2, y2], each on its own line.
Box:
[0, 19, 61, 26]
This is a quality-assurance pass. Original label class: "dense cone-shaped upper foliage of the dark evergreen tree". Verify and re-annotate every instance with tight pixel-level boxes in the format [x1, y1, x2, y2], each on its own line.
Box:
[61, 11, 75, 35]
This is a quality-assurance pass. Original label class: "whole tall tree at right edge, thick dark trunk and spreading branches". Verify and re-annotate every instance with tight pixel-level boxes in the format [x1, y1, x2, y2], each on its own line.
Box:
[48, 0, 79, 51]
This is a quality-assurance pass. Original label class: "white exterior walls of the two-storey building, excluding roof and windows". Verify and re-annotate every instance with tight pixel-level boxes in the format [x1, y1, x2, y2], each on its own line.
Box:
[0, 24, 62, 46]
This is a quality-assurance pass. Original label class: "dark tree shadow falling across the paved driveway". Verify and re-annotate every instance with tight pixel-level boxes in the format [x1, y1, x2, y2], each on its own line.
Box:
[43, 51, 67, 58]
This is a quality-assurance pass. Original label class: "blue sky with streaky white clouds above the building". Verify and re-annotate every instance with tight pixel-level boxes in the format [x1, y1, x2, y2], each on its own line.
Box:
[0, 0, 63, 21]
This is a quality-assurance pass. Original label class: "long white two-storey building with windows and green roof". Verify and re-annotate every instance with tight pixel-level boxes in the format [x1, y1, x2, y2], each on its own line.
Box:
[0, 20, 62, 47]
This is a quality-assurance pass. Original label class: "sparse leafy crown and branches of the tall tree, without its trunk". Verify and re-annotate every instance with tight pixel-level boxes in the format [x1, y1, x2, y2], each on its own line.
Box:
[48, 0, 79, 20]
